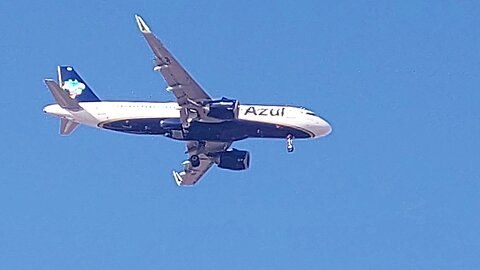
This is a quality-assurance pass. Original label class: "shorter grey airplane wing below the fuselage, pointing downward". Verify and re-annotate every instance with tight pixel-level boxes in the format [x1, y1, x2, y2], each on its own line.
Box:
[173, 141, 231, 186]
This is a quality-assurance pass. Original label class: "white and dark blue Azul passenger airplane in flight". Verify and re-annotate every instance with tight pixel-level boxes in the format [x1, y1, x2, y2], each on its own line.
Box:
[43, 15, 332, 186]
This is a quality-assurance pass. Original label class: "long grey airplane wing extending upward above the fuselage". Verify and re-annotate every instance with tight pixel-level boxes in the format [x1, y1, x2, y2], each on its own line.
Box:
[135, 15, 211, 108]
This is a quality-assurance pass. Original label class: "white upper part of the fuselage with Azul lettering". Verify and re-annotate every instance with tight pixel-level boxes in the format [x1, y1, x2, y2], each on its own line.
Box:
[44, 101, 331, 138]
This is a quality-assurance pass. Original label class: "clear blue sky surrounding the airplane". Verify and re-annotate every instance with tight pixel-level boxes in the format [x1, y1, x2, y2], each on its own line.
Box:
[0, 0, 480, 269]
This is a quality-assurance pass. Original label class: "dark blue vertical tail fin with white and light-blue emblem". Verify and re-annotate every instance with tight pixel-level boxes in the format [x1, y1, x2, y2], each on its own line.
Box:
[58, 66, 100, 102]
